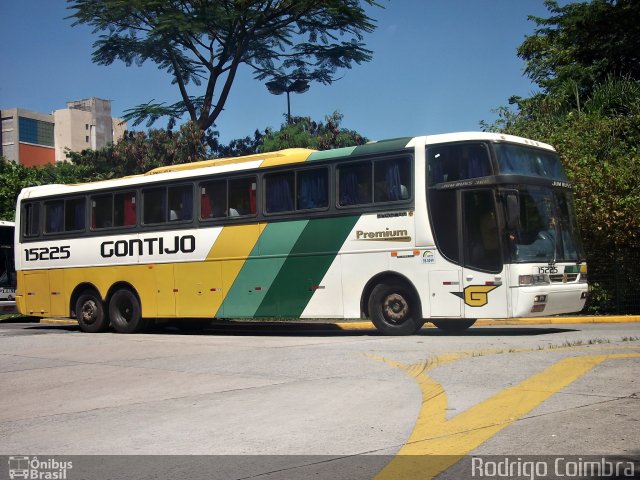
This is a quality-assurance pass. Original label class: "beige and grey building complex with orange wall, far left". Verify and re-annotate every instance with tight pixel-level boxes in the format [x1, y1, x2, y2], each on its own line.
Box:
[0, 97, 127, 166]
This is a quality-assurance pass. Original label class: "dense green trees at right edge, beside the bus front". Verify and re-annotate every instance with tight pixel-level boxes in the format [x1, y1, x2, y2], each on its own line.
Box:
[482, 0, 640, 313]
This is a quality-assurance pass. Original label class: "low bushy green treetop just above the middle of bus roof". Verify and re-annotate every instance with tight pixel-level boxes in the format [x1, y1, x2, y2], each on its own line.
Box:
[261, 112, 367, 152]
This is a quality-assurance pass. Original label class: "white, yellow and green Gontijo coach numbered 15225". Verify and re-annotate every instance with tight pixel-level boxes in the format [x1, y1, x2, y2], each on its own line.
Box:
[16, 132, 588, 335]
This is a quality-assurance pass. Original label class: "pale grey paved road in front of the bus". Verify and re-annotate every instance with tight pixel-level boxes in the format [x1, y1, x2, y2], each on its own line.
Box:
[0, 323, 640, 479]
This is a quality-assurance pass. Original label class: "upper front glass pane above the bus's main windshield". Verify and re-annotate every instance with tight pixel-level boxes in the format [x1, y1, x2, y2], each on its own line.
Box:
[495, 143, 567, 182]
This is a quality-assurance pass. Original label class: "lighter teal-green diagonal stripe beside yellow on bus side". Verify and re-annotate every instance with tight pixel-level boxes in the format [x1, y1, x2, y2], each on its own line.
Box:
[216, 220, 309, 318]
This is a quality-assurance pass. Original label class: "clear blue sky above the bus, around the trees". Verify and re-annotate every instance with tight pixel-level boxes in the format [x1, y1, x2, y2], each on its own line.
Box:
[0, 0, 566, 141]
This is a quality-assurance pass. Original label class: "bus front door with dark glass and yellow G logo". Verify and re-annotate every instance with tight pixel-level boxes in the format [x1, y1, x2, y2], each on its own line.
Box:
[459, 189, 509, 318]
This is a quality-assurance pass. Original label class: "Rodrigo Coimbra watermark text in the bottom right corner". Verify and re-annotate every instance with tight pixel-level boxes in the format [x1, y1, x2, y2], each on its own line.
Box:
[471, 457, 636, 480]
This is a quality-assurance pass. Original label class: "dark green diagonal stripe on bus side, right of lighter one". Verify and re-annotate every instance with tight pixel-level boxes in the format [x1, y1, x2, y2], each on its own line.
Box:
[255, 216, 360, 317]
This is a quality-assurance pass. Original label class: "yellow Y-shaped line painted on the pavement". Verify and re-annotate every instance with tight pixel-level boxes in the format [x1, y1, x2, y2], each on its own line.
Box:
[376, 353, 640, 480]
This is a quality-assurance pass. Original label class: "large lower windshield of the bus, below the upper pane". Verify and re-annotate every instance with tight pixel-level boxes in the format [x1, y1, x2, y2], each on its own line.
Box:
[508, 186, 584, 263]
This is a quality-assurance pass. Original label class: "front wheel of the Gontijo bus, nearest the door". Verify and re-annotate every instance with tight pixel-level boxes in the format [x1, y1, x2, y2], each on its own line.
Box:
[369, 283, 424, 335]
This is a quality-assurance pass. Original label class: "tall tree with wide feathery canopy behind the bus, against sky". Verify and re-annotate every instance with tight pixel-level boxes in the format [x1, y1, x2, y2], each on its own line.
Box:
[67, 0, 377, 131]
